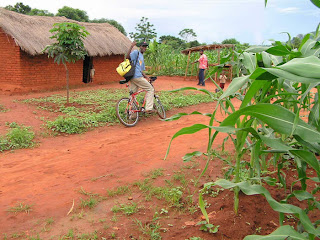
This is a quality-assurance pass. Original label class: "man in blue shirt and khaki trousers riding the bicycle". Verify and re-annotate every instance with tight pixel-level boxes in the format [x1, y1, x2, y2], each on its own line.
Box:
[126, 41, 154, 113]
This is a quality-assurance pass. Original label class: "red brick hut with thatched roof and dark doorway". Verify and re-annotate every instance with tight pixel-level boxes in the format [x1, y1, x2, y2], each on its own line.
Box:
[0, 8, 131, 92]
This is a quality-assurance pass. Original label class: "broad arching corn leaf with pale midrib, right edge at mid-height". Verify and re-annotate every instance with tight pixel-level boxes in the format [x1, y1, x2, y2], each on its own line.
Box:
[220, 103, 320, 143]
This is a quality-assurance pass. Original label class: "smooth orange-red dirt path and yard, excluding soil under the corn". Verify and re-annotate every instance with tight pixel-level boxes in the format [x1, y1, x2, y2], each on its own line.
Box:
[0, 78, 231, 233]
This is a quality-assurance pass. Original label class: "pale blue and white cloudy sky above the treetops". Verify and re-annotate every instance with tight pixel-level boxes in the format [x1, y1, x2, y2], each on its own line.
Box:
[0, 0, 320, 45]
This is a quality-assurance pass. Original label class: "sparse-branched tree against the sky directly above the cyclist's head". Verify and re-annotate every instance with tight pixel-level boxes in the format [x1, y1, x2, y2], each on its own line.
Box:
[129, 17, 157, 42]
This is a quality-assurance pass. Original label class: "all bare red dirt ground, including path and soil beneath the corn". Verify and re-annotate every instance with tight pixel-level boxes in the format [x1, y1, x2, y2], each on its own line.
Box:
[0, 77, 316, 239]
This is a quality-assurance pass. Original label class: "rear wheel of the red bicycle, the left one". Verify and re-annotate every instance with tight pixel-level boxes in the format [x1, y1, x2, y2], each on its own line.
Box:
[116, 98, 139, 127]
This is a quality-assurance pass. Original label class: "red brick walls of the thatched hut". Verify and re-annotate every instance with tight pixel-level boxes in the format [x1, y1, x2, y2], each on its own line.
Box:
[0, 29, 123, 92]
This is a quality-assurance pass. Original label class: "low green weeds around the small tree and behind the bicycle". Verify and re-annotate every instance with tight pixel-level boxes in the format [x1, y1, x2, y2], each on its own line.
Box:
[22, 89, 212, 134]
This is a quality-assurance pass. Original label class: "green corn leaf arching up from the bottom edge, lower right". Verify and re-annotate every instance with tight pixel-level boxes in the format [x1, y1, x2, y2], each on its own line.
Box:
[243, 225, 306, 240]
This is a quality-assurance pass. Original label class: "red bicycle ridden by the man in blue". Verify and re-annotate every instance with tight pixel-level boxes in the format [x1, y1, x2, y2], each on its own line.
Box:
[116, 77, 166, 127]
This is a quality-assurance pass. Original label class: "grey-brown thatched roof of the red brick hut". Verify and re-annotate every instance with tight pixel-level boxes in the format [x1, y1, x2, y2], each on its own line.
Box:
[0, 8, 131, 57]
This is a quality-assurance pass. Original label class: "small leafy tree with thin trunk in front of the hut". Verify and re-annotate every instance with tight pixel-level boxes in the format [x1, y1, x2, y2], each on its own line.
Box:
[43, 22, 89, 104]
